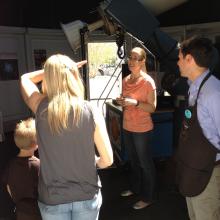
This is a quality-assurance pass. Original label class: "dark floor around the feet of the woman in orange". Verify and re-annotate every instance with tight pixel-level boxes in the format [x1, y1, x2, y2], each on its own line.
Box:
[99, 160, 189, 220]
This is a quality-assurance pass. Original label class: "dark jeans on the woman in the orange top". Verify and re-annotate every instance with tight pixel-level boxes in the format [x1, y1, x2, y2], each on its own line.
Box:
[123, 130, 155, 202]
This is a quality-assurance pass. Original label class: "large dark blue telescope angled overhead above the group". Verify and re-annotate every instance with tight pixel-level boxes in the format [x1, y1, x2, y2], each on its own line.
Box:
[61, 0, 220, 96]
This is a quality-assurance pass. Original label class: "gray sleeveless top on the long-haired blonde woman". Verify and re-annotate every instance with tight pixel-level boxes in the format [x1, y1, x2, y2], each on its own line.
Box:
[36, 99, 101, 205]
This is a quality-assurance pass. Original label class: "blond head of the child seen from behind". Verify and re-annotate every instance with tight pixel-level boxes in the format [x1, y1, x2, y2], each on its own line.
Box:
[14, 118, 37, 150]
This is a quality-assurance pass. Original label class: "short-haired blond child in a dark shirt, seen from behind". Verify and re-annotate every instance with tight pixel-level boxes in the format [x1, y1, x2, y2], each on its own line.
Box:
[4, 118, 42, 220]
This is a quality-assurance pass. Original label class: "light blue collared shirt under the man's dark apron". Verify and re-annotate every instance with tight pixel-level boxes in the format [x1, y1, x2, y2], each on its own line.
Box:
[189, 70, 220, 160]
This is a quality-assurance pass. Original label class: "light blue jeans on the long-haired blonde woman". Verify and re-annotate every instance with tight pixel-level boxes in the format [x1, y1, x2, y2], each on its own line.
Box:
[38, 190, 102, 220]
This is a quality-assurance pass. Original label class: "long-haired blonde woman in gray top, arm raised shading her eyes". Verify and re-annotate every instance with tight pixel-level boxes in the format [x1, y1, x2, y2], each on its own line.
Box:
[21, 54, 113, 220]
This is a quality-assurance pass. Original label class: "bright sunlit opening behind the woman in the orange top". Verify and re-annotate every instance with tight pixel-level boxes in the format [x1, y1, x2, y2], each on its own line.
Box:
[88, 42, 122, 115]
